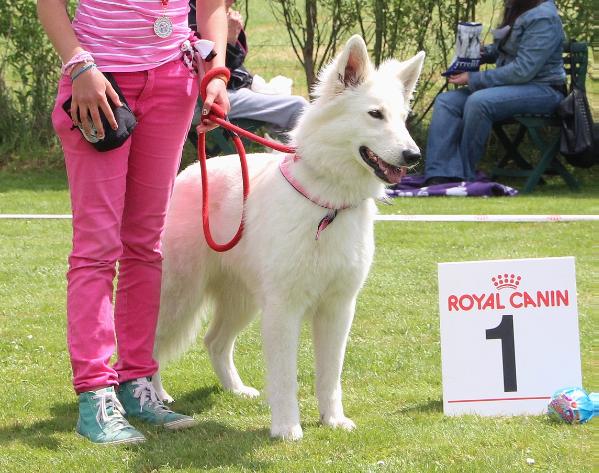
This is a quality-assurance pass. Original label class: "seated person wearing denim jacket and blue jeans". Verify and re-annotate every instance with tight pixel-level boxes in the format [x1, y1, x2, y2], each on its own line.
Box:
[425, 0, 566, 185]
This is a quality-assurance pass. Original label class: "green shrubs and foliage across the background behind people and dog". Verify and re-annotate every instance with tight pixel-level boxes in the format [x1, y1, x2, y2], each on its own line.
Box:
[0, 0, 595, 167]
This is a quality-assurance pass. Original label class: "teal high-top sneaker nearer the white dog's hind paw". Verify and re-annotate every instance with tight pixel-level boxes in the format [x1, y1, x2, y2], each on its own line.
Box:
[118, 378, 196, 430]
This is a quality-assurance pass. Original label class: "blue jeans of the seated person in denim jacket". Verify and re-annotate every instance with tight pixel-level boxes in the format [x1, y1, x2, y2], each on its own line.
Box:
[424, 84, 564, 181]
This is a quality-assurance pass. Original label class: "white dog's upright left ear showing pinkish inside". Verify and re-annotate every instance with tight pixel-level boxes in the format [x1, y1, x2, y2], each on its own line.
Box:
[315, 35, 372, 96]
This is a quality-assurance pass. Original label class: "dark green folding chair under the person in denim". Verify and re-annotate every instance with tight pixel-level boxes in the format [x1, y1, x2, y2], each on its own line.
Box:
[492, 42, 588, 193]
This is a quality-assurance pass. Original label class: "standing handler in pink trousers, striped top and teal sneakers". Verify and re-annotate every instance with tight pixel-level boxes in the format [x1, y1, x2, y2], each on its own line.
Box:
[38, 0, 229, 444]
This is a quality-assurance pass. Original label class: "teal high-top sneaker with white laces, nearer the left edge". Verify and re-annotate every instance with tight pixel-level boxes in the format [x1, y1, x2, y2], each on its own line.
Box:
[77, 387, 146, 445]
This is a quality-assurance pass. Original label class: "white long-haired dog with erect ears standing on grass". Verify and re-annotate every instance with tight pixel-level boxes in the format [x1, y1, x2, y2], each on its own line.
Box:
[154, 36, 424, 439]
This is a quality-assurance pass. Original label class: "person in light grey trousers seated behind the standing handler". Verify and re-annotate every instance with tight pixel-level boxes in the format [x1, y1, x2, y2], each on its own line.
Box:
[189, 0, 308, 140]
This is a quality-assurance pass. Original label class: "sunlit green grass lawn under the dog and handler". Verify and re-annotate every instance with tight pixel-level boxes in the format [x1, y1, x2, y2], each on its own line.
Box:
[0, 170, 599, 472]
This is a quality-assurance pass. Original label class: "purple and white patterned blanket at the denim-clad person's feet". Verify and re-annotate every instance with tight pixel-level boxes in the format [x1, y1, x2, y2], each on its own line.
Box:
[387, 171, 518, 197]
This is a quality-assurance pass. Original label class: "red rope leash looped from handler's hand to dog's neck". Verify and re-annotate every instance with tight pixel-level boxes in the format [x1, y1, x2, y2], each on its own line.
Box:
[198, 67, 295, 252]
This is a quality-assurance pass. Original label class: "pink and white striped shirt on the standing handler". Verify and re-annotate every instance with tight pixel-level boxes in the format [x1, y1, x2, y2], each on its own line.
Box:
[73, 0, 195, 72]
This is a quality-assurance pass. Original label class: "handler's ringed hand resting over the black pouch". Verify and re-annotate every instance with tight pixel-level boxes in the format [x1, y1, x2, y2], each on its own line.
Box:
[71, 65, 122, 139]
